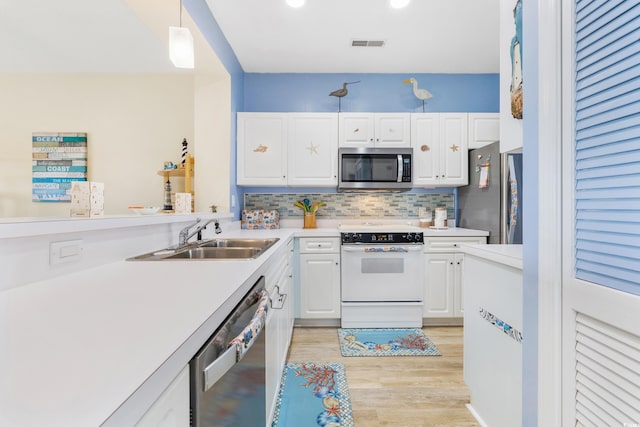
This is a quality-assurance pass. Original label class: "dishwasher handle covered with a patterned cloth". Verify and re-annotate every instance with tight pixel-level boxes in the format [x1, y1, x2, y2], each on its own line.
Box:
[203, 289, 270, 392]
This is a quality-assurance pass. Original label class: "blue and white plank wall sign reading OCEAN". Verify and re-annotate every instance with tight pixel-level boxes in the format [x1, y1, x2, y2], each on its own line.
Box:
[31, 132, 87, 202]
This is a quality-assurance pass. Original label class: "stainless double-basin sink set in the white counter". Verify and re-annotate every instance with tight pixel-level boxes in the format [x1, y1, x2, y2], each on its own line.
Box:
[127, 238, 280, 261]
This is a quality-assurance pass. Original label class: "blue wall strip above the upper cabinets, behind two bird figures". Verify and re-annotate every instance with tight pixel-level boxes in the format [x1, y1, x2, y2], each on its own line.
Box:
[244, 73, 500, 113]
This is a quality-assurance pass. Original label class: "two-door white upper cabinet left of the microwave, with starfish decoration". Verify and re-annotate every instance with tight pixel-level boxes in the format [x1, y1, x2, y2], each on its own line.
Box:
[237, 113, 338, 187]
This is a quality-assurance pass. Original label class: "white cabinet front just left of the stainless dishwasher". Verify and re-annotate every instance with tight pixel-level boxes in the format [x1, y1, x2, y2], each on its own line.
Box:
[136, 365, 191, 427]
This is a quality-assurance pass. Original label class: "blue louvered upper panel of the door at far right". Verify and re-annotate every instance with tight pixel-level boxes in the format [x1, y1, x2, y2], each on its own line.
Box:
[575, 0, 640, 295]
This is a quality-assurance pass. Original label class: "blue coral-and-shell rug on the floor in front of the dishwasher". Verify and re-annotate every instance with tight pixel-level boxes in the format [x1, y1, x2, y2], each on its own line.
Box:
[271, 362, 354, 427]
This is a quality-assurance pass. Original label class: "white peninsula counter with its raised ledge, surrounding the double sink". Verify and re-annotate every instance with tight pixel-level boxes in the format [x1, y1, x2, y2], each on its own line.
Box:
[0, 214, 486, 427]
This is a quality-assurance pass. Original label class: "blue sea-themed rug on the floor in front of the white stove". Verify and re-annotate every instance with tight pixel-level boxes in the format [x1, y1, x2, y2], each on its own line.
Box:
[338, 328, 441, 357]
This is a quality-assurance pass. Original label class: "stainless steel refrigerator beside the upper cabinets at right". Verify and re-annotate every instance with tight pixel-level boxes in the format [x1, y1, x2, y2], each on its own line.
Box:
[457, 142, 523, 244]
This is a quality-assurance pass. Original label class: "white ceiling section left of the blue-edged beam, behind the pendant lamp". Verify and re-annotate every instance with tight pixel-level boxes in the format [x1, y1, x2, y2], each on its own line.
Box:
[0, 0, 226, 73]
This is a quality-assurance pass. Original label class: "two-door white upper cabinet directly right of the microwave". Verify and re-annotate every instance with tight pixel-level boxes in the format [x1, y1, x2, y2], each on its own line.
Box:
[411, 113, 469, 187]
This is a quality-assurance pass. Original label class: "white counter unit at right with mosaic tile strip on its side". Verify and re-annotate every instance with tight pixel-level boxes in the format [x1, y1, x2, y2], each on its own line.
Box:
[461, 245, 527, 426]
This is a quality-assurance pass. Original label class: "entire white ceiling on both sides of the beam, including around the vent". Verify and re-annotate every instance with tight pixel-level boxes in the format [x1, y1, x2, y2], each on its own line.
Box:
[0, 0, 499, 73]
